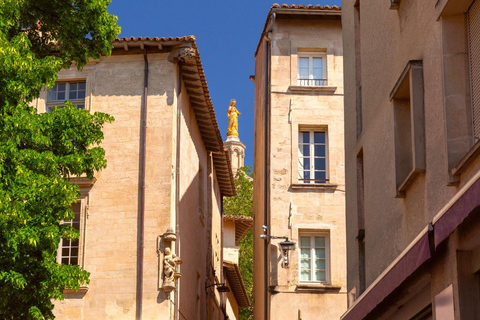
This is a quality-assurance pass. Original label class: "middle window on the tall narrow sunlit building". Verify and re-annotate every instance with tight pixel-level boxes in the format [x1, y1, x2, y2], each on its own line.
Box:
[298, 130, 328, 183]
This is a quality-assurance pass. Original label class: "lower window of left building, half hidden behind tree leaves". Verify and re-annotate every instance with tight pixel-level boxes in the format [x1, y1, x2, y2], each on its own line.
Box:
[57, 202, 82, 265]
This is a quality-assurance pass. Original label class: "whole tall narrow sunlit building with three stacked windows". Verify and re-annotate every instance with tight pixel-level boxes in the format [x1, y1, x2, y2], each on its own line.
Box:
[254, 5, 347, 319]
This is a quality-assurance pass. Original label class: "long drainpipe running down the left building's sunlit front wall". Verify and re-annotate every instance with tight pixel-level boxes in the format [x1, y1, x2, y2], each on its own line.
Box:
[136, 48, 148, 320]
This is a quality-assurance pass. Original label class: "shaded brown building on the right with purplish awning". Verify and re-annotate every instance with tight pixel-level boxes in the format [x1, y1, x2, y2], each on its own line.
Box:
[342, 0, 480, 320]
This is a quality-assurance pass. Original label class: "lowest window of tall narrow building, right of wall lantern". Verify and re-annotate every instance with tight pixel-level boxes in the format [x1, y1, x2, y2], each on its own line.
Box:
[300, 233, 329, 283]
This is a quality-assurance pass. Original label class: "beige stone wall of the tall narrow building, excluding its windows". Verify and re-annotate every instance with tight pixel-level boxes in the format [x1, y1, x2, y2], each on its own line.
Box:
[254, 14, 347, 319]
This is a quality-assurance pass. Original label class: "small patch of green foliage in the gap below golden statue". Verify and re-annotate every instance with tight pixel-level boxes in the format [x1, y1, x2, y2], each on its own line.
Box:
[223, 166, 253, 320]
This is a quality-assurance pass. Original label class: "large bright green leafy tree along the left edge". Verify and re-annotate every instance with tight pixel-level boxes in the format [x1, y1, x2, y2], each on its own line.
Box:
[0, 0, 120, 319]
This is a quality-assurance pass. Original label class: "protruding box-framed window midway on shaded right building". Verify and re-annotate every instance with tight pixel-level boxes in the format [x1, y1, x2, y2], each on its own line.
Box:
[390, 60, 425, 197]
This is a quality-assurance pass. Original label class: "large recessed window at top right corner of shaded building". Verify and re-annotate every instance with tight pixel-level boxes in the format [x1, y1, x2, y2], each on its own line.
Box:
[435, 0, 480, 181]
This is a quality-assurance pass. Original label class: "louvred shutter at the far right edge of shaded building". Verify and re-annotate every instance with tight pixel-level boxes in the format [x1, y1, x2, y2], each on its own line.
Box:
[468, 0, 480, 141]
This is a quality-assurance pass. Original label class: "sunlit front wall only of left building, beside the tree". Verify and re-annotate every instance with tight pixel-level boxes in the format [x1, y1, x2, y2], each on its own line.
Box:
[48, 55, 175, 319]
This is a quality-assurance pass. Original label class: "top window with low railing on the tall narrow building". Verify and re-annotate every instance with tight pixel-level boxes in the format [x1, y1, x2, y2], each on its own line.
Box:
[298, 53, 327, 86]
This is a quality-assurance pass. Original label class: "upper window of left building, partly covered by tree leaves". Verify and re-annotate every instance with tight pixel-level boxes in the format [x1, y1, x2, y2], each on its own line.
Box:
[47, 81, 86, 112]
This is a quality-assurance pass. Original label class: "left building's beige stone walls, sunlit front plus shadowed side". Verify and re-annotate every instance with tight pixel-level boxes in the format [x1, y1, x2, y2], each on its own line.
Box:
[34, 48, 227, 319]
